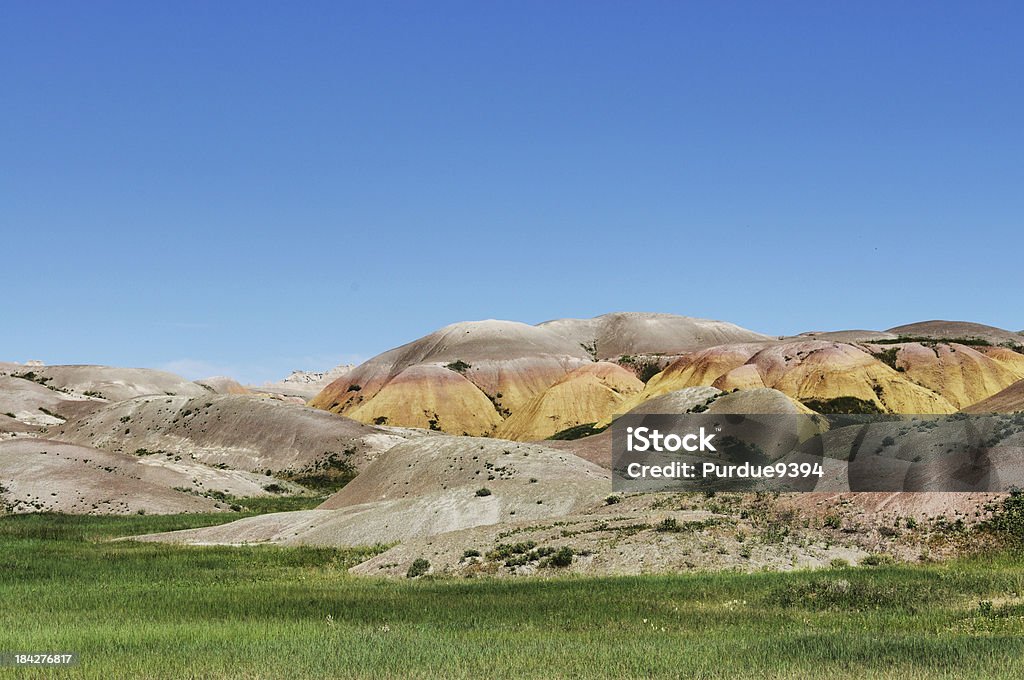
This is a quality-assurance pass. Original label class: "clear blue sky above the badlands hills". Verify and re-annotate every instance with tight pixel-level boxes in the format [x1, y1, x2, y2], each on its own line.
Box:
[0, 0, 1024, 381]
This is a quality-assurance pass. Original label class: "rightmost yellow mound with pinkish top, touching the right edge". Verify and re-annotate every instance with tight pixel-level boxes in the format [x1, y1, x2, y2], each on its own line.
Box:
[868, 342, 1024, 405]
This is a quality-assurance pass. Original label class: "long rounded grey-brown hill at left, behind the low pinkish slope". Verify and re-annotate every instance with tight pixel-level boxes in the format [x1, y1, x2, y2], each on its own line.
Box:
[49, 392, 407, 472]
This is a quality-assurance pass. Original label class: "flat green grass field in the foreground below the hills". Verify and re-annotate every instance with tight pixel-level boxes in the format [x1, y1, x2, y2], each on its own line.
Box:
[0, 505, 1024, 679]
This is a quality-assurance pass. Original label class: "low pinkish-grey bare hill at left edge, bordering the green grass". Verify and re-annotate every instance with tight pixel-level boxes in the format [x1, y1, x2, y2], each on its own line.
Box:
[0, 438, 297, 514]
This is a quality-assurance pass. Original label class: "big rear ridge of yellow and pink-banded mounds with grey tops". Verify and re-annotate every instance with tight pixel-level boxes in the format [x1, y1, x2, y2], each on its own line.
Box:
[309, 313, 1024, 441]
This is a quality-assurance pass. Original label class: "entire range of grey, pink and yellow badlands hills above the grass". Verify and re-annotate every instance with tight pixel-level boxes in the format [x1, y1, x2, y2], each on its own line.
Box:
[0, 313, 1024, 576]
